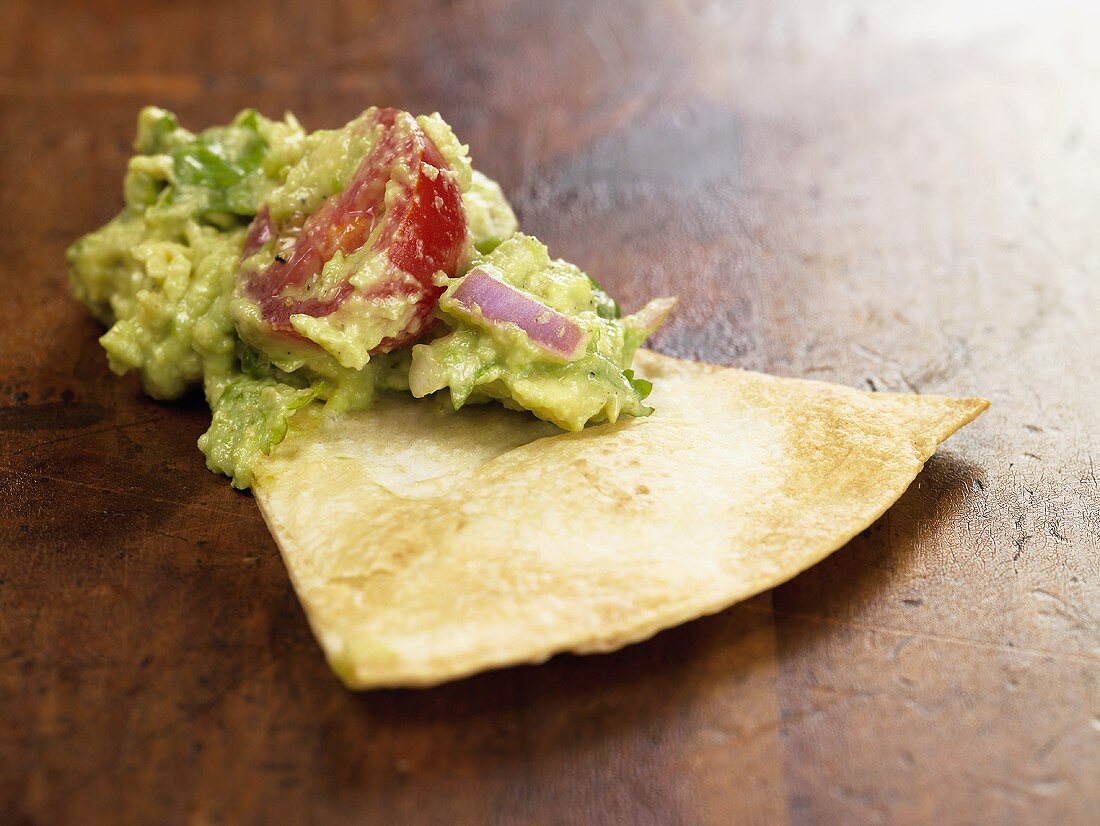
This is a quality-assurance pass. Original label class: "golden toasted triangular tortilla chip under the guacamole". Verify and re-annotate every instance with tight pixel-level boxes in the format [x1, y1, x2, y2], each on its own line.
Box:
[254, 351, 988, 689]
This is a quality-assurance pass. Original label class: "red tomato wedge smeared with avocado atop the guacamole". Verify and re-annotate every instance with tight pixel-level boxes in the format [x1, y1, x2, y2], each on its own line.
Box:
[238, 109, 466, 353]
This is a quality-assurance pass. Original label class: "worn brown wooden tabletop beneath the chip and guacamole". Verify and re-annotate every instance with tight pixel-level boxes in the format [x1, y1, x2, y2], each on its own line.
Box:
[0, 0, 1100, 824]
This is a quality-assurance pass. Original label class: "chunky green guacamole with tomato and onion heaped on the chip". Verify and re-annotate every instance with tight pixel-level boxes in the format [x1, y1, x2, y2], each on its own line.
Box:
[67, 107, 675, 488]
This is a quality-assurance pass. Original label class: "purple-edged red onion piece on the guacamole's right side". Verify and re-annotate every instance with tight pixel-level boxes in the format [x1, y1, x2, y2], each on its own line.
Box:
[451, 266, 589, 361]
